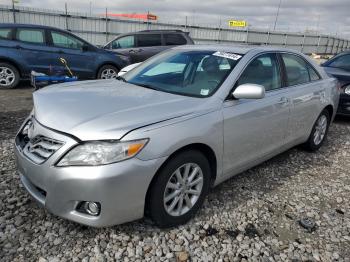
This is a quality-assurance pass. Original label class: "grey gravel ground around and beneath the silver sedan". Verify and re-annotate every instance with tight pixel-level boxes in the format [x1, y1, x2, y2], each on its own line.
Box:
[0, 89, 350, 262]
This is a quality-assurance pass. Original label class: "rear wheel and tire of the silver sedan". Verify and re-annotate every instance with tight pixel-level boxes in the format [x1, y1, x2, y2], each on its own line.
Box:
[303, 109, 330, 152]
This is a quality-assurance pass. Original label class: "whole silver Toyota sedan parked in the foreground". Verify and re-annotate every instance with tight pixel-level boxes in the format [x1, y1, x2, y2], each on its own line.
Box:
[15, 46, 339, 227]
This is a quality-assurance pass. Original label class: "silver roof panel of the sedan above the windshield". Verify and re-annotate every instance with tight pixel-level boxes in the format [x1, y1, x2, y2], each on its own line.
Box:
[173, 44, 300, 55]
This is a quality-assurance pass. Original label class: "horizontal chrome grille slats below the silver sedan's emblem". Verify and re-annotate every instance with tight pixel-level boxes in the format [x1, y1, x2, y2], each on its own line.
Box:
[23, 135, 63, 164]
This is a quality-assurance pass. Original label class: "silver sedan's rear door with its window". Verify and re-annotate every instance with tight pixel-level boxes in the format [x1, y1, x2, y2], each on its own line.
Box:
[280, 53, 326, 142]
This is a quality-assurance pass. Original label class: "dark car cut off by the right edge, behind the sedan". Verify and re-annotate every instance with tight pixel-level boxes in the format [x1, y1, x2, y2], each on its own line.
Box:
[322, 51, 350, 116]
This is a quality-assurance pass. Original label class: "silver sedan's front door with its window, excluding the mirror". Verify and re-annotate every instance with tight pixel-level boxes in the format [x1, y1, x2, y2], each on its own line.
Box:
[223, 53, 290, 176]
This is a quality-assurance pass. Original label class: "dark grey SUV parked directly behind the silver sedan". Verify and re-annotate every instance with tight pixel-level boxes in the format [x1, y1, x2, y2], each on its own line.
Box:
[104, 30, 194, 63]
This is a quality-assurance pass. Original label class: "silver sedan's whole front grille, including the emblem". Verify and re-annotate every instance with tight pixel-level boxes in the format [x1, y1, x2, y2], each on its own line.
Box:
[16, 120, 64, 164]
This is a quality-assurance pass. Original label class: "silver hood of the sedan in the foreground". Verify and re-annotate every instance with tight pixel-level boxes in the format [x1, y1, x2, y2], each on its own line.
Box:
[33, 80, 208, 140]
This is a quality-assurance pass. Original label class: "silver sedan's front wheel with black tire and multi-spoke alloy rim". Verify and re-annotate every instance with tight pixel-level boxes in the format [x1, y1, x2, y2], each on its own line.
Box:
[148, 150, 210, 228]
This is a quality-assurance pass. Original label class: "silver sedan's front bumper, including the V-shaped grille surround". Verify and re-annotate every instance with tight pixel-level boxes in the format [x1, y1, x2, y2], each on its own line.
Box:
[15, 117, 164, 227]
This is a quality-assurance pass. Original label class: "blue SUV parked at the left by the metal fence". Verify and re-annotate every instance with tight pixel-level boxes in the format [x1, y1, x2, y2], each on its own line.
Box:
[0, 24, 129, 88]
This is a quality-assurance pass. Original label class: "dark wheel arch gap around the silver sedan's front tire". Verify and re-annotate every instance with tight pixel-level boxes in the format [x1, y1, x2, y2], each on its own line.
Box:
[144, 143, 217, 214]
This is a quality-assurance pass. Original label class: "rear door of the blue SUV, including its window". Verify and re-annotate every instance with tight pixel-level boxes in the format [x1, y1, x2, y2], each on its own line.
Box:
[14, 27, 54, 74]
